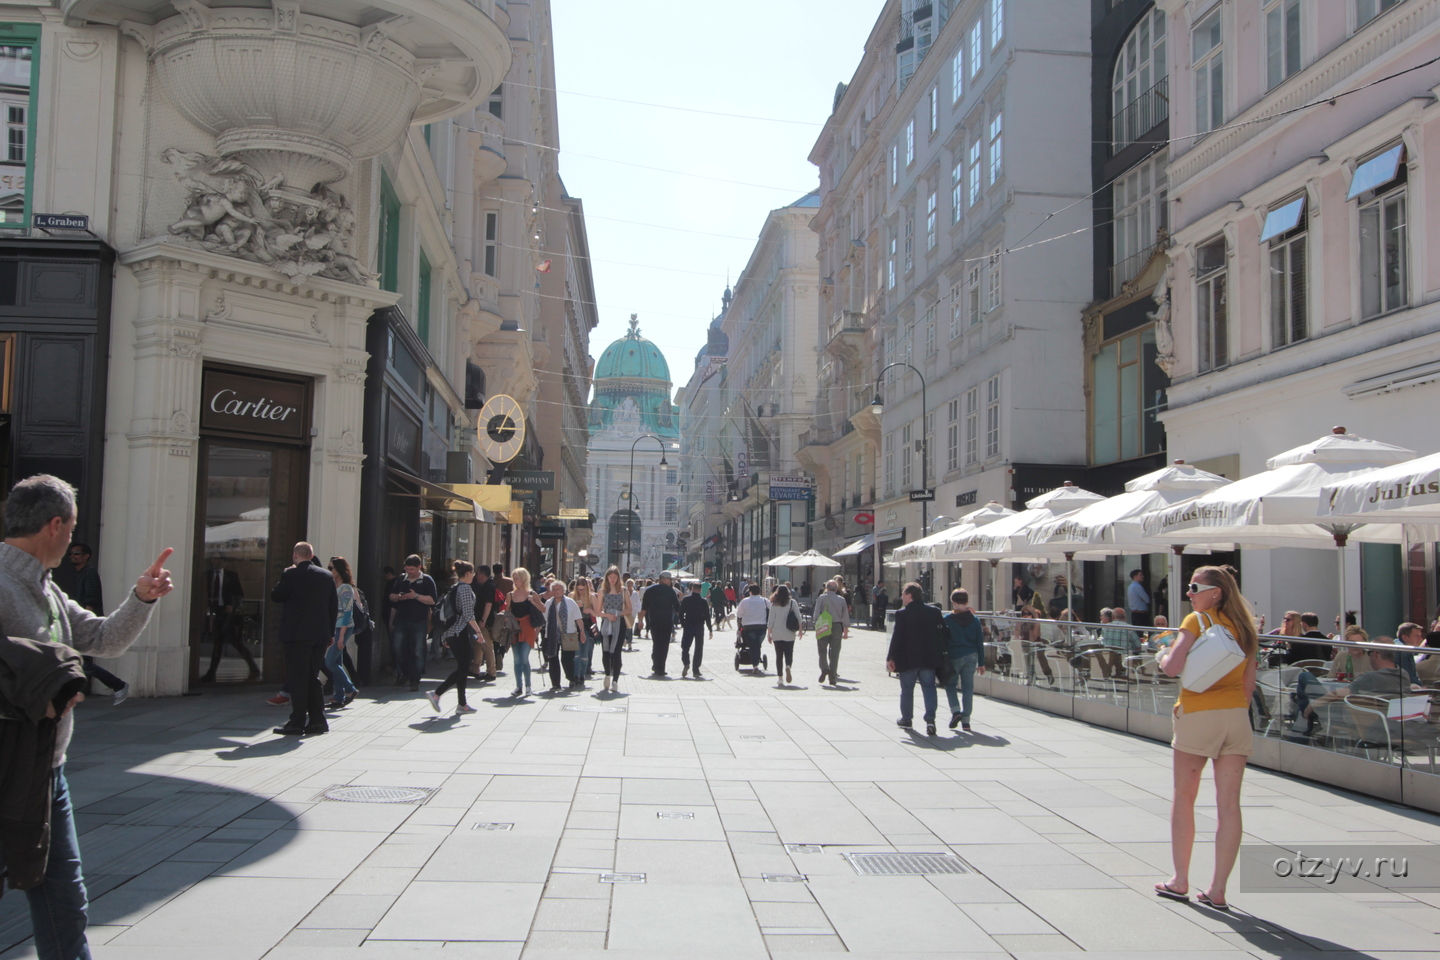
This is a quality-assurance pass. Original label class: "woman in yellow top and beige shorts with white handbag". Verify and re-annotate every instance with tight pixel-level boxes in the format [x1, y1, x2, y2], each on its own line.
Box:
[1155, 567, 1260, 911]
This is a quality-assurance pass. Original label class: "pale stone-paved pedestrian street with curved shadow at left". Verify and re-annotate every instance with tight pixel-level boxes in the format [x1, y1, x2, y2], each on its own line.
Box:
[0, 632, 1440, 960]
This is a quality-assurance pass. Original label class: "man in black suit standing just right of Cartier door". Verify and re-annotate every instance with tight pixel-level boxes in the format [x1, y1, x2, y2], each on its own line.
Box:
[271, 541, 340, 737]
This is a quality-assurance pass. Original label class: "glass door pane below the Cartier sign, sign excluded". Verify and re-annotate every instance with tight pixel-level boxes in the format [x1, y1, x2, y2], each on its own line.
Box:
[199, 443, 270, 682]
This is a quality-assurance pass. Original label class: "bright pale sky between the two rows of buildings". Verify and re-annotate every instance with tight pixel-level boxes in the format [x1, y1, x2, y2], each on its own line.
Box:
[552, 0, 884, 389]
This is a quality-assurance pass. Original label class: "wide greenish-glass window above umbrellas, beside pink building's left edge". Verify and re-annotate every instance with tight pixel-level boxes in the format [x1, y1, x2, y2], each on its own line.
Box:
[1090, 327, 1168, 463]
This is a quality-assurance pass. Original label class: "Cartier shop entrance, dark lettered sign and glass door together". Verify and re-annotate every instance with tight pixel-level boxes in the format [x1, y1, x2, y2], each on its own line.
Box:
[190, 364, 314, 682]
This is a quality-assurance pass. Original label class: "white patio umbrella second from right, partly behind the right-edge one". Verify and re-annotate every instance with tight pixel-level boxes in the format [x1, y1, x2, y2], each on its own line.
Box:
[1142, 426, 1414, 612]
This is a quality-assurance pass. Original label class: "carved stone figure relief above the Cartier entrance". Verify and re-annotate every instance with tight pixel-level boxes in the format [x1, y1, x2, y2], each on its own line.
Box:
[160, 147, 373, 284]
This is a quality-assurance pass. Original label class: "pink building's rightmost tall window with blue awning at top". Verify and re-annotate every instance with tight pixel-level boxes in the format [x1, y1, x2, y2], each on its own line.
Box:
[1351, 154, 1410, 318]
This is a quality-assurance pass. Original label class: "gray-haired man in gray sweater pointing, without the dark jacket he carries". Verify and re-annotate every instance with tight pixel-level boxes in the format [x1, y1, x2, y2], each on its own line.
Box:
[0, 475, 174, 960]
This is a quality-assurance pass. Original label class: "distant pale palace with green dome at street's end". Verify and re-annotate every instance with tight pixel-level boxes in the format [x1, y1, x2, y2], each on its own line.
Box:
[589, 314, 684, 574]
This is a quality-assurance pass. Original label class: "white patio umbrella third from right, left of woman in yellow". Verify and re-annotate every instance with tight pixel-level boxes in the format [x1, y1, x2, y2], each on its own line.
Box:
[1028, 461, 1230, 619]
